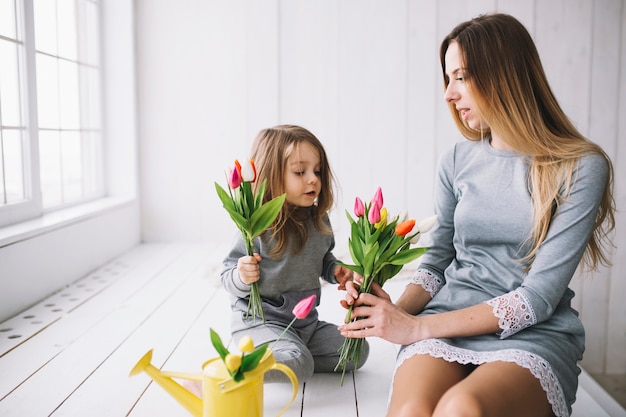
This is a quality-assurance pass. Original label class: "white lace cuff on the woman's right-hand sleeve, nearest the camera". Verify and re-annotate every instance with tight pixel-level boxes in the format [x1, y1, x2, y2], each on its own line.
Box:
[485, 290, 537, 339]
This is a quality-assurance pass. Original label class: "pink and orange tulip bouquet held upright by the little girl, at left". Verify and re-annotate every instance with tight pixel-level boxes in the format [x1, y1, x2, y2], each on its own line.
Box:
[215, 159, 286, 321]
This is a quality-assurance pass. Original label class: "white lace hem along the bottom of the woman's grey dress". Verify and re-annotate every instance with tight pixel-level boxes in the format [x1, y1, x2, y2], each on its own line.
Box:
[394, 339, 569, 417]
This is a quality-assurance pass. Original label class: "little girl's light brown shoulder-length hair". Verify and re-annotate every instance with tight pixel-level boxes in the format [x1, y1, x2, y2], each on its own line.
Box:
[251, 125, 335, 257]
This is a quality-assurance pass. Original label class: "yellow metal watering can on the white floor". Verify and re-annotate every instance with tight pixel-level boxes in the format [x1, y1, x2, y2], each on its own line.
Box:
[130, 349, 298, 417]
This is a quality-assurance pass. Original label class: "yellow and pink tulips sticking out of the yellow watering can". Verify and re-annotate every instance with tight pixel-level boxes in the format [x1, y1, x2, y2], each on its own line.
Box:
[210, 294, 317, 382]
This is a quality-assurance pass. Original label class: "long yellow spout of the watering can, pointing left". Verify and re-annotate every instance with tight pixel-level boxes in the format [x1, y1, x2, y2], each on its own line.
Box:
[130, 349, 202, 417]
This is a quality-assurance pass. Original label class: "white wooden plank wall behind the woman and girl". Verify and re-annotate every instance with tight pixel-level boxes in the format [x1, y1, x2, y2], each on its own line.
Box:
[136, 0, 626, 373]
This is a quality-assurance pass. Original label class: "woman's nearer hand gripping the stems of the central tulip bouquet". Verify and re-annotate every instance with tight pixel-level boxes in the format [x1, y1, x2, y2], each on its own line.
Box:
[339, 283, 419, 344]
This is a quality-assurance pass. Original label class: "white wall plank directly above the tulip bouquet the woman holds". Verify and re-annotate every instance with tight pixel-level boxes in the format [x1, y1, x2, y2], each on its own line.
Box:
[337, 0, 407, 221]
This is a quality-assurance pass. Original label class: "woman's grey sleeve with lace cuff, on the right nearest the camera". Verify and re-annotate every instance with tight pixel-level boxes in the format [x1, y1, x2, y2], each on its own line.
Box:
[486, 155, 608, 339]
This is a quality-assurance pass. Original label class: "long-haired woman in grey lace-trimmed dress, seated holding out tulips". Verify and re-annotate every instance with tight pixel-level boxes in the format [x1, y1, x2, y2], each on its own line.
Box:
[340, 14, 615, 417]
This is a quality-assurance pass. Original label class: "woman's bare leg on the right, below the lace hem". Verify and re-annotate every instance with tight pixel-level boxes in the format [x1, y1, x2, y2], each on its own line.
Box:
[433, 362, 553, 417]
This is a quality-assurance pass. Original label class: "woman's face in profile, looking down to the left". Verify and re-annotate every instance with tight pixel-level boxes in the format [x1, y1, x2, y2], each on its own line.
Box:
[445, 42, 488, 130]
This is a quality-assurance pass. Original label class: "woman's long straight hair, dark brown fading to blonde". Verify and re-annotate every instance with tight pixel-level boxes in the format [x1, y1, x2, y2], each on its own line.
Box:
[440, 14, 615, 270]
